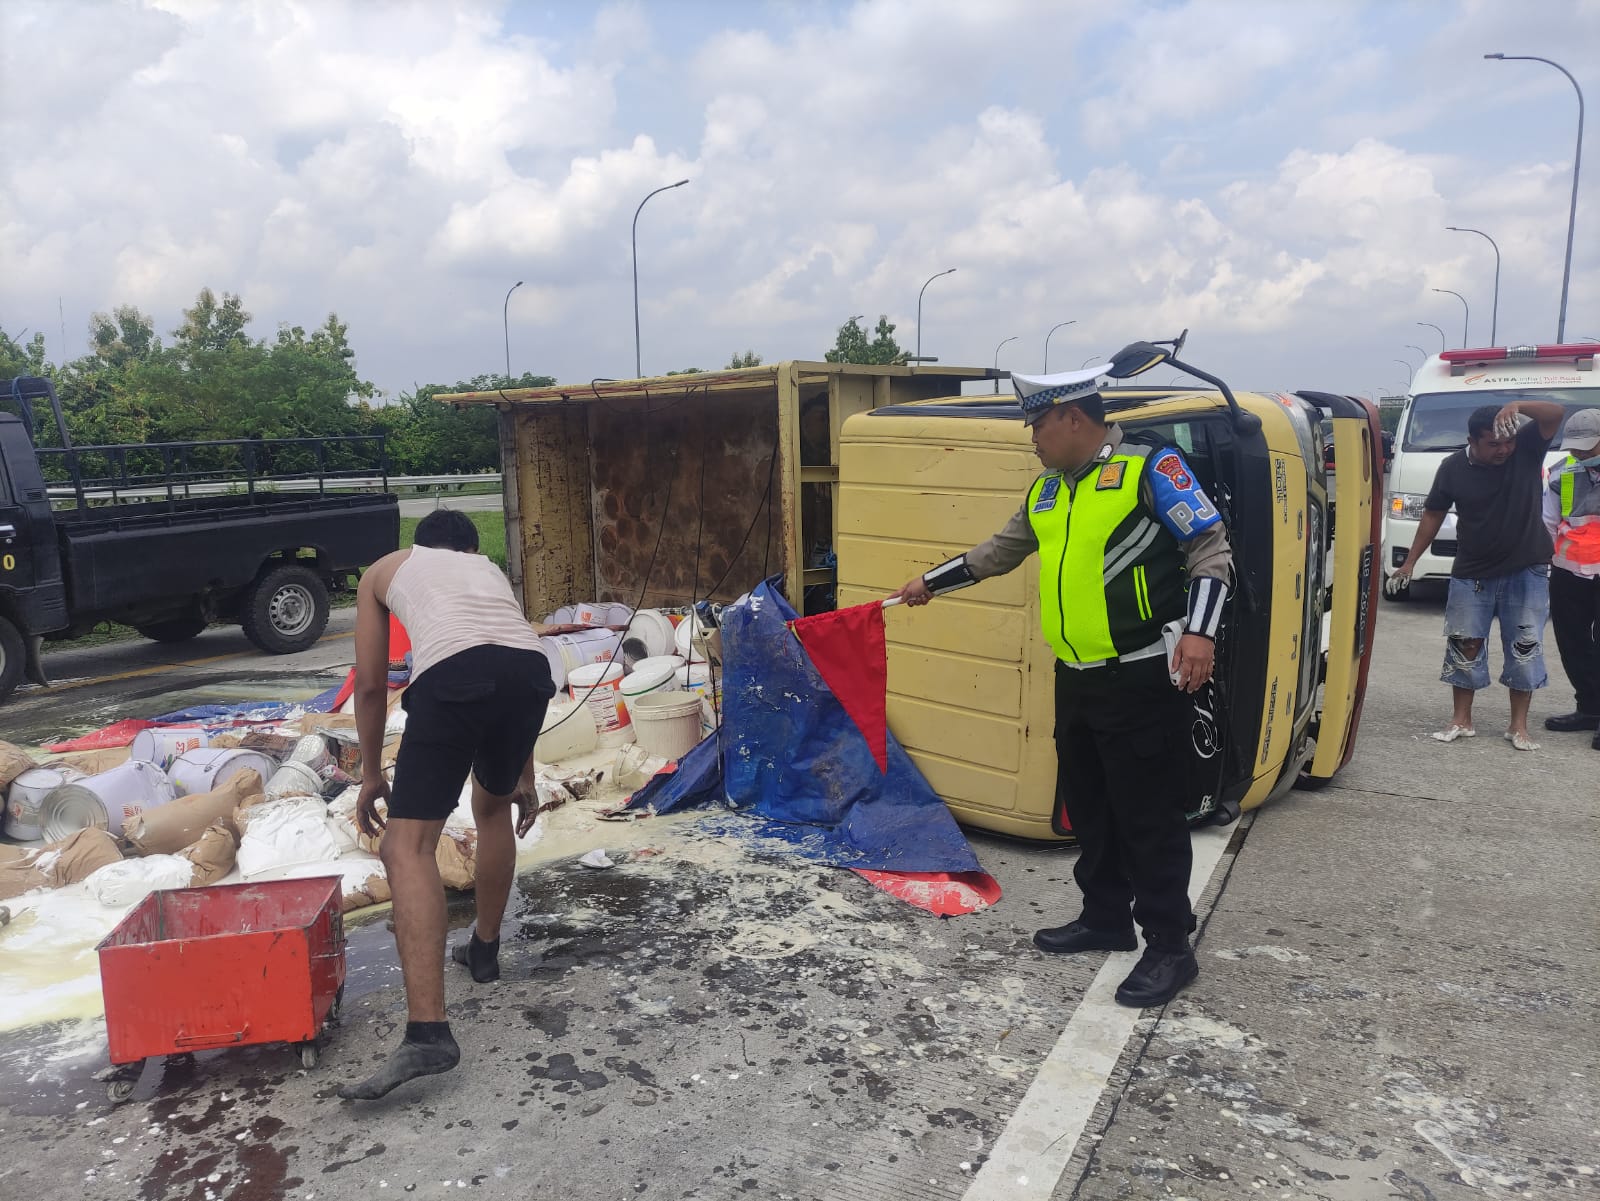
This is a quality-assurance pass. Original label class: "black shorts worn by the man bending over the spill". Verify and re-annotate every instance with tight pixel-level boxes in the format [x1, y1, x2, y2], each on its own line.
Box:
[389, 646, 555, 822]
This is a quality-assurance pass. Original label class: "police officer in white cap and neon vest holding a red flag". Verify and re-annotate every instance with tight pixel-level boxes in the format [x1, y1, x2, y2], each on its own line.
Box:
[894, 365, 1232, 1007]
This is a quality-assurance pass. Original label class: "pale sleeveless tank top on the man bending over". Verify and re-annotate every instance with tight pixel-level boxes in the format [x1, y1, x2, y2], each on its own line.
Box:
[384, 547, 544, 683]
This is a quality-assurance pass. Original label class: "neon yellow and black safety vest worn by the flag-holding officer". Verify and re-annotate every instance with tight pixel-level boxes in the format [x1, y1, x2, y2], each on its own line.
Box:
[1027, 445, 1184, 664]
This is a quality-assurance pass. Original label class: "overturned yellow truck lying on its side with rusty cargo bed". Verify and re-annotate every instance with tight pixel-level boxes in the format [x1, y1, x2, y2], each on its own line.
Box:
[440, 339, 1382, 840]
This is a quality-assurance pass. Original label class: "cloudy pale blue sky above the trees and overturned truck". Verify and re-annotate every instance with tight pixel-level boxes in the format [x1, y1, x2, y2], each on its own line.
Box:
[0, 0, 1600, 393]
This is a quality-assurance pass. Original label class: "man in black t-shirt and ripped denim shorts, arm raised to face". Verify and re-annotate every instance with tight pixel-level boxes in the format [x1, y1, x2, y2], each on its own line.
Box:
[1386, 400, 1565, 750]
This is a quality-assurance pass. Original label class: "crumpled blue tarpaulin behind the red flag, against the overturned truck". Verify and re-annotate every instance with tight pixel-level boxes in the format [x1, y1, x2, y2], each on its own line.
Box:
[630, 584, 982, 872]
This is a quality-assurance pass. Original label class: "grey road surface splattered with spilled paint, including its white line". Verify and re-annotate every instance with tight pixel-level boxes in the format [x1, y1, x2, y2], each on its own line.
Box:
[0, 600, 1600, 1201]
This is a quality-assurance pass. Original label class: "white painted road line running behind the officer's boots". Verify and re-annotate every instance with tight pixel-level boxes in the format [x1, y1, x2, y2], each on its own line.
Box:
[963, 827, 1234, 1201]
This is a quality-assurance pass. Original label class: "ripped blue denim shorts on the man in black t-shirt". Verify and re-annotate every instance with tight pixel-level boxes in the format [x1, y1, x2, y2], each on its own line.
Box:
[1438, 565, 1550, 692]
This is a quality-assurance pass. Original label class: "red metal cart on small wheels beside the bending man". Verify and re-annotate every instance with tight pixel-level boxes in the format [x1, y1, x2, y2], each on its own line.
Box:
[96, 876, 344, 1102]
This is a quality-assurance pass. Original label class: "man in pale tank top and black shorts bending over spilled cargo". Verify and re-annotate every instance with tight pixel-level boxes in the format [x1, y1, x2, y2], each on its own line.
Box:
[339, 509, 555, 1100]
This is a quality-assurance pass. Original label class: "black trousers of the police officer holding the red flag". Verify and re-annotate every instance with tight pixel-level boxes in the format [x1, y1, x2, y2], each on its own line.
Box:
[1056, 656, 1194, 947]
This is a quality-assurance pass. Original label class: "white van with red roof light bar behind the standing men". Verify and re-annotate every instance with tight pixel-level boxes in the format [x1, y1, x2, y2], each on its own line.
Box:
[1382, 342, 1600, 600]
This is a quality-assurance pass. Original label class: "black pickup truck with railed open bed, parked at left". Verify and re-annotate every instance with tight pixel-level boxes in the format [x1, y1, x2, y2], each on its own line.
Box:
[0, 377, 400, 702]
